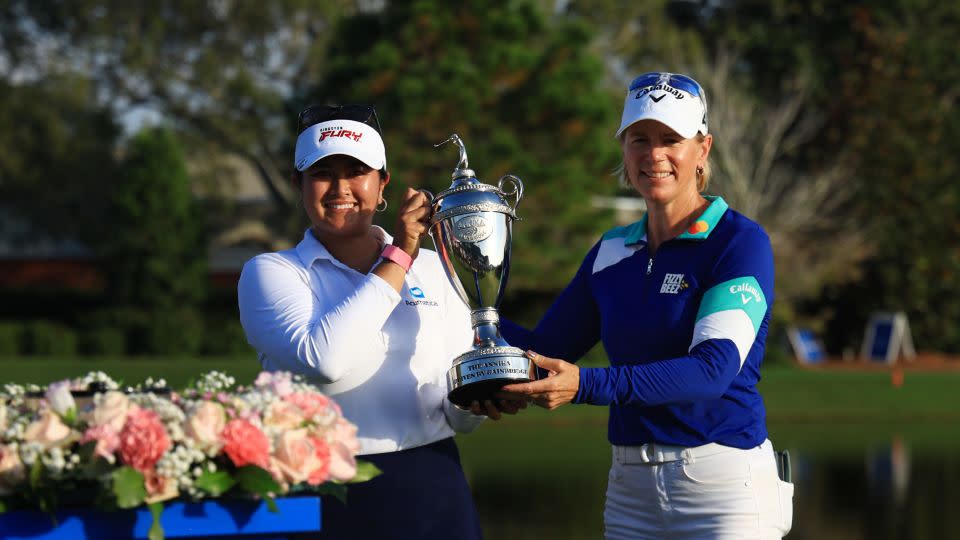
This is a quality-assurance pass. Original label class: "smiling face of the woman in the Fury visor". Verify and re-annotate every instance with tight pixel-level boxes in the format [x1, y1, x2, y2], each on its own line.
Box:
[300, 155, 390, 241]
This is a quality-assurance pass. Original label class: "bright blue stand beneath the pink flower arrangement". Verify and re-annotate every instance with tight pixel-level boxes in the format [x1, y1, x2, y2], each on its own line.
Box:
[0, 497, 320, 540]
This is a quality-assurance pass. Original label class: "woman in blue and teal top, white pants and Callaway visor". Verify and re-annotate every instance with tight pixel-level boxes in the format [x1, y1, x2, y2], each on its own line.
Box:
[503, 73, 793, 539]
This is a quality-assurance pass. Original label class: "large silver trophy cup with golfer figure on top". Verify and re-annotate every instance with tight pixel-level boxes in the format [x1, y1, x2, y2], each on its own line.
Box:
[430, 134, 536, 407]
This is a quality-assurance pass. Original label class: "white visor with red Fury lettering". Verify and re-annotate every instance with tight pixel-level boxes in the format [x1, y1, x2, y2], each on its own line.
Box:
[293, 120, 387, 172]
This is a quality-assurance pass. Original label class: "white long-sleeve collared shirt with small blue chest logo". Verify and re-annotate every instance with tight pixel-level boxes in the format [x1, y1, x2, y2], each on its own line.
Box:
[237, 227, 483, 454]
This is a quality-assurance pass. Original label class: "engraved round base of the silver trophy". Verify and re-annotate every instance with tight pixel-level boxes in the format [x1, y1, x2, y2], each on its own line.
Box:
[447, 347, 537, 408]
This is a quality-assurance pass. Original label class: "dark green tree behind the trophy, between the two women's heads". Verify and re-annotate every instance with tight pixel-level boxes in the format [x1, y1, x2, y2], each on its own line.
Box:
[301, 0, 622, 290]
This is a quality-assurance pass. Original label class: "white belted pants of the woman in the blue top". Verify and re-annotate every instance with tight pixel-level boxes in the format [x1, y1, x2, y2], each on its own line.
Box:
[603, 440, 793, 540]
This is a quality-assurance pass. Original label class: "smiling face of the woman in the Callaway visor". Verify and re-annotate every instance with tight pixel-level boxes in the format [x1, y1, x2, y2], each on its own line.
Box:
[622, 120, 713, 205]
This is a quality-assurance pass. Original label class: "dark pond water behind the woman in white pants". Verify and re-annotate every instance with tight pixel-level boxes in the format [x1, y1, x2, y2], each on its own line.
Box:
[458, 416, 960, 540]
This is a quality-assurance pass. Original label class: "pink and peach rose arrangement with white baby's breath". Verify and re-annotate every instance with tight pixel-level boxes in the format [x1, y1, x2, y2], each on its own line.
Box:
[0, 371, 380, 538]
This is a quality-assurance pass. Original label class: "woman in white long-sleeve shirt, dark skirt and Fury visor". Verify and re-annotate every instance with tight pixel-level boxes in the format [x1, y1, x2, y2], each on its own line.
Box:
[238, 105, 497, 539]
